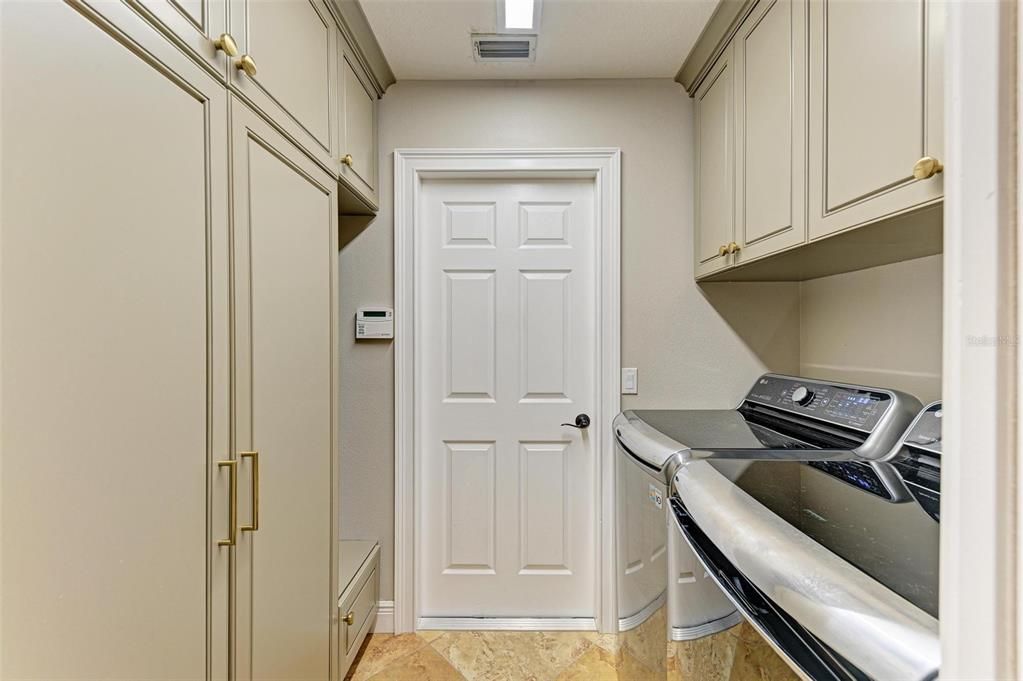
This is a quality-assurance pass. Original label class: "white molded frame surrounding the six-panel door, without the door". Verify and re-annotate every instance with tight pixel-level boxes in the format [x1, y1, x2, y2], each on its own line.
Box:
[394, 147, 621, 633]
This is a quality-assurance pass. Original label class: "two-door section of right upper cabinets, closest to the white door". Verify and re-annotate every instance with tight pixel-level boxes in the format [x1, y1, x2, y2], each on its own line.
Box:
[694, 0, 806, 277]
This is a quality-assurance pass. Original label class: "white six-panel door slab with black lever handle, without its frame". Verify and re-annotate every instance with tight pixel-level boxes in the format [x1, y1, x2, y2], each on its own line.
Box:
[415, 179, 598, 618]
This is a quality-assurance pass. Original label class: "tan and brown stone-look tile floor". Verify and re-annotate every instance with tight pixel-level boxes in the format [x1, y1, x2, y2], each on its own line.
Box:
[347, 618, 797, 681]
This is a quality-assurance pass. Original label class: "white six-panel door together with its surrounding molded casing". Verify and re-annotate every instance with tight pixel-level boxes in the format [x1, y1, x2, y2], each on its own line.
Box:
[395, 149, 620, 632]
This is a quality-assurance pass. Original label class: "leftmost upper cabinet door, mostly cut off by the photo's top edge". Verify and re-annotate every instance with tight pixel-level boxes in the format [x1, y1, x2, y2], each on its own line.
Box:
[132, 0, 231, 79]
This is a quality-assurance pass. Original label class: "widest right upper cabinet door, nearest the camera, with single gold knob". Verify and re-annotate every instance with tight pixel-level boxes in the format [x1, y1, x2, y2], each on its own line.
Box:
[809, 0, 944, 239]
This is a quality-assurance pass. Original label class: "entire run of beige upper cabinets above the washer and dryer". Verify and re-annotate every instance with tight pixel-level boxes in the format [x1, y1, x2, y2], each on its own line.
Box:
[679, 0, 944, 280]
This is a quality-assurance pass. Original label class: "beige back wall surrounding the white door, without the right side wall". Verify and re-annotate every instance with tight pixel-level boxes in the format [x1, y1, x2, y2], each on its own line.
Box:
[341, 80, 799, 600]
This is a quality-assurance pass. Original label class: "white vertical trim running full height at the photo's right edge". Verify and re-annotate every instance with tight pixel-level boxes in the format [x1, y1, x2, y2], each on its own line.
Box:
[940, 2, 1020, 679]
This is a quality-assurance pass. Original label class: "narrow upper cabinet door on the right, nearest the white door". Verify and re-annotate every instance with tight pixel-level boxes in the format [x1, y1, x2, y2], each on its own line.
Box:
[695, 44, 736, 277]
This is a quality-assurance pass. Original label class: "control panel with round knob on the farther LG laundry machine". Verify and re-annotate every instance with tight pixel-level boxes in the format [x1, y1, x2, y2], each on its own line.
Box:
[746, 374, 892, 433]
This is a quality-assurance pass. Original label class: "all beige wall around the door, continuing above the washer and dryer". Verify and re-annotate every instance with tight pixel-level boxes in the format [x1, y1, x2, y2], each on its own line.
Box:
[341, 80, 941, 600]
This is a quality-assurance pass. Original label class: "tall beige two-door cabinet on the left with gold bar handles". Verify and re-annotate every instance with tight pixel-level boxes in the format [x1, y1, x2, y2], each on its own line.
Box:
[0, 2, 339, 681]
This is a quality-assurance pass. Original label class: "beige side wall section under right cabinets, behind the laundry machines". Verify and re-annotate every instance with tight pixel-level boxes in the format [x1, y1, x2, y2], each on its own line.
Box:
[799, 256, 941, 403]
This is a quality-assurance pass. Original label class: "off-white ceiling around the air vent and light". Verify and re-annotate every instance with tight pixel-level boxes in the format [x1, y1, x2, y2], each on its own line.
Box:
[361, 0, 717, 81]
